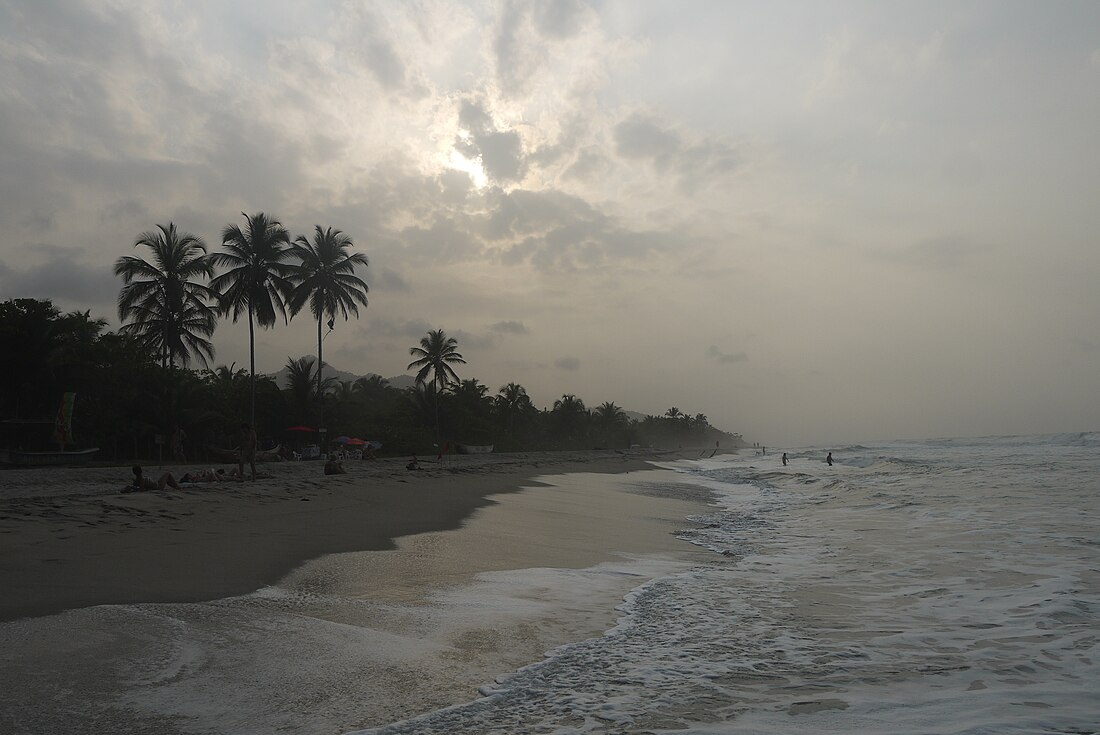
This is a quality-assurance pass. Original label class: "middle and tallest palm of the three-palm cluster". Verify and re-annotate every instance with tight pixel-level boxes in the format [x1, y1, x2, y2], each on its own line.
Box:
[210, 212, 292, 428]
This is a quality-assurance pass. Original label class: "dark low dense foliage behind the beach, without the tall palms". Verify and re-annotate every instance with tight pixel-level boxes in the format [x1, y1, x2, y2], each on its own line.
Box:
[0, 299, 737, 461]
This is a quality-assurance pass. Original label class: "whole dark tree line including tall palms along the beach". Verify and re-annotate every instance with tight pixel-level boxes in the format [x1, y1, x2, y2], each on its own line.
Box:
[0, 212, 739, 460]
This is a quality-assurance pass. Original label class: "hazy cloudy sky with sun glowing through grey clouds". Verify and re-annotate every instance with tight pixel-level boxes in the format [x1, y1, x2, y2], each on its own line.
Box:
[0, 0, 1100, 447]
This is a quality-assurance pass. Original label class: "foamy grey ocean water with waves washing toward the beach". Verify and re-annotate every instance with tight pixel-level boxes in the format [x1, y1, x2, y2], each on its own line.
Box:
[352, 434, 1100, 735]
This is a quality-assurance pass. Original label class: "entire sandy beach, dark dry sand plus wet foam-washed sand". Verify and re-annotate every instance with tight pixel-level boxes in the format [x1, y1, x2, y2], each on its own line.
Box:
[0, 451, 706, 733]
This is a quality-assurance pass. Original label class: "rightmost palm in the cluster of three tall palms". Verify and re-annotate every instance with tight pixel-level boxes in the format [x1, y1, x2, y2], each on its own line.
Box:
[289, 224, 367, 426]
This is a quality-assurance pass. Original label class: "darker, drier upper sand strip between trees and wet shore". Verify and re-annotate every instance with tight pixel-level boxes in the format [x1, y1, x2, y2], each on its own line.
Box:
[0, 450, 704, 621]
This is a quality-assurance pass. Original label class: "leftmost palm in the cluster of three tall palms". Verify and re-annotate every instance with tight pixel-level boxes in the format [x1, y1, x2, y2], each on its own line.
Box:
[114, 222, 218, 366]
